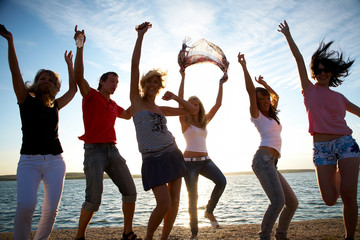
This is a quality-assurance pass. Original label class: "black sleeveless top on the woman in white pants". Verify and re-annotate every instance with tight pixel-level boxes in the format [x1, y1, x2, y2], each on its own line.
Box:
[19, 94, 63, 155]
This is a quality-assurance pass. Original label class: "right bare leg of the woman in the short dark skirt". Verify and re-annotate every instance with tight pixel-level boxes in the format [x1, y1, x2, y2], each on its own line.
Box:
[161, 178, 181, 240]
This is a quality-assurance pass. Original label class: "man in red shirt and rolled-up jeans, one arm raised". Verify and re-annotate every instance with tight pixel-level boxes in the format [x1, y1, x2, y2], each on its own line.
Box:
[74, 28, 139, 240]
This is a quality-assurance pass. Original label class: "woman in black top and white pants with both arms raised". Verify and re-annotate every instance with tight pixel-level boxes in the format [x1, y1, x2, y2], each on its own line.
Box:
[0, 25, 77, 239]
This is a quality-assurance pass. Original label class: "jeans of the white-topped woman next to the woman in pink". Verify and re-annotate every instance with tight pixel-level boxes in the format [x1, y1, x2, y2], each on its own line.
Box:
[252, 149, 298, 240]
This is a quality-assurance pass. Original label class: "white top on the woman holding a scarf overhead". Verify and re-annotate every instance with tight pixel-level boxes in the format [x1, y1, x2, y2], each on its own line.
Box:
[184, 125, 207, 152]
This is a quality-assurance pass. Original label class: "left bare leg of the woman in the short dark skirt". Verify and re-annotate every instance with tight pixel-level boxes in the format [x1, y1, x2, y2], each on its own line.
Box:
[145, 184, 171, 240]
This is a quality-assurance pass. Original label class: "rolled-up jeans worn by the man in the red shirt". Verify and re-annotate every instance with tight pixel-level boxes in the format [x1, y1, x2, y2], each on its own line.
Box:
[82, 143, 136, 212]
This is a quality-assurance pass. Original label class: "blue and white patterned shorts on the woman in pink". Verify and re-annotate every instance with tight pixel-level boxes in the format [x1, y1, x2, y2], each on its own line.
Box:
[313, 135, 360, 166]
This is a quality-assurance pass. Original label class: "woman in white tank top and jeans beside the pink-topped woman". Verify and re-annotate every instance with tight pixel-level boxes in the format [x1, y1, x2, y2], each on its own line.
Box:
[238, 53, 298, 240]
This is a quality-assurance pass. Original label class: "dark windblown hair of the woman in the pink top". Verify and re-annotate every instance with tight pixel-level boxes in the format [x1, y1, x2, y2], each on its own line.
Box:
[310, 41, 355, 87]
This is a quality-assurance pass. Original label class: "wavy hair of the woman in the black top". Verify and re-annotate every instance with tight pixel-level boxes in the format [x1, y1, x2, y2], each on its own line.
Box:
[25, 69, 61, 107]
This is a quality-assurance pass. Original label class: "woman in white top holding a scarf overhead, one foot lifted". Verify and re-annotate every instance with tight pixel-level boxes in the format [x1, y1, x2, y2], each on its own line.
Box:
[178, 69, 227, 239]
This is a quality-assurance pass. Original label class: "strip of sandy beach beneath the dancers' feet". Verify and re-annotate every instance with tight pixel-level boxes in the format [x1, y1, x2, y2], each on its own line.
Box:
[0, 219, 360, 240]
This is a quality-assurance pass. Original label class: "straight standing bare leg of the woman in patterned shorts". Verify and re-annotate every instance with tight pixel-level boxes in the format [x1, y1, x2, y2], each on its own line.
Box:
[339, 158, 360, 238]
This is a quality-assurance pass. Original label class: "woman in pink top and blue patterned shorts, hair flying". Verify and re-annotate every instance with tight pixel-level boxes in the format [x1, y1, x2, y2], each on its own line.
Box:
[278, 21, 360, 239]
